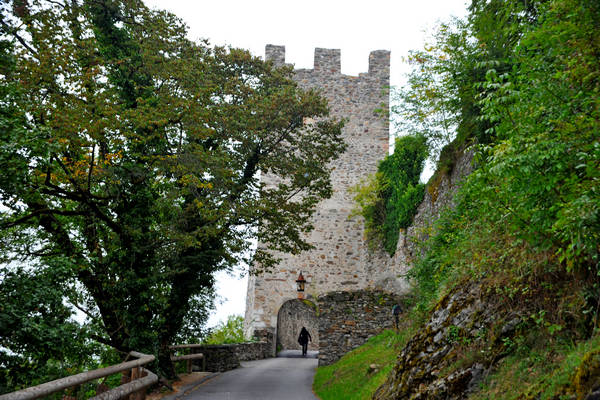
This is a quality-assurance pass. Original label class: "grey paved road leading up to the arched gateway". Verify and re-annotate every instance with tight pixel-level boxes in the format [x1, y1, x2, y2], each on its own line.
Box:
[180, 351, 318, 400]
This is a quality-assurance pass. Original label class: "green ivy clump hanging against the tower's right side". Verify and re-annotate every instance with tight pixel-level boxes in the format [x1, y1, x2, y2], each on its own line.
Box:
[353, 136, 428, 255]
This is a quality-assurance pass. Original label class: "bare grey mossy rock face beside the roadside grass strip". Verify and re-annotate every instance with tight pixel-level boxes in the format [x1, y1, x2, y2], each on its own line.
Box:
[374, 283, 520, 400]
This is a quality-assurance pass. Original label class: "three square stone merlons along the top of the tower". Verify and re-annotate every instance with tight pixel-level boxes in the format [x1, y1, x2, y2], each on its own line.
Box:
[265, 44, 390, 79]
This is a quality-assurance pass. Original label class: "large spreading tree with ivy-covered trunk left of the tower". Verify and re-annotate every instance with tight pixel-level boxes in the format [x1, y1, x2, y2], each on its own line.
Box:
[0, 0, 344, 375]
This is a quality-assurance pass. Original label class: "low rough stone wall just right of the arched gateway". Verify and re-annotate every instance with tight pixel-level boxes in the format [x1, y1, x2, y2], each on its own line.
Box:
[318, 290, 404, 365]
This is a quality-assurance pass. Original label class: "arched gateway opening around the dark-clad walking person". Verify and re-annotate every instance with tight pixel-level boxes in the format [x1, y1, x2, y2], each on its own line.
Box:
[277, 299, 319, 351]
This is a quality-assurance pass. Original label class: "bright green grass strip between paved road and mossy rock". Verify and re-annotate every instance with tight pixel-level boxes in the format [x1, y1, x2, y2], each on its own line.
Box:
[313, 329, 412, 400]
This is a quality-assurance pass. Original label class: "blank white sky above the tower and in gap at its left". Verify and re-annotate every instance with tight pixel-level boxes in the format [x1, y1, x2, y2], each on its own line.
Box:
[145, 0, 468, 326]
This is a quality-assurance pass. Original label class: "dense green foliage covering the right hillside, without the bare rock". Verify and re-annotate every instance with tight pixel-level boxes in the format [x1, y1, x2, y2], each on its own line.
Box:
[386, 0, 600, 399]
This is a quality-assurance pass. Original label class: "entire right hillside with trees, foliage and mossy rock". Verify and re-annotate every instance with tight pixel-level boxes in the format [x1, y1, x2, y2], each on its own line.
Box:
[374, 0, 600, 400]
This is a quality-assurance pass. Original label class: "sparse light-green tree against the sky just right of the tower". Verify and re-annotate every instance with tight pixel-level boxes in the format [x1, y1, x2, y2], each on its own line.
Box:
[392, 20, 490, 156]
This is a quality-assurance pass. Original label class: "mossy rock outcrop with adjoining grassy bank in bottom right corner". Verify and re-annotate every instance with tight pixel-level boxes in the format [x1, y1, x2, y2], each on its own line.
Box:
[373, 280, 600, 400]
